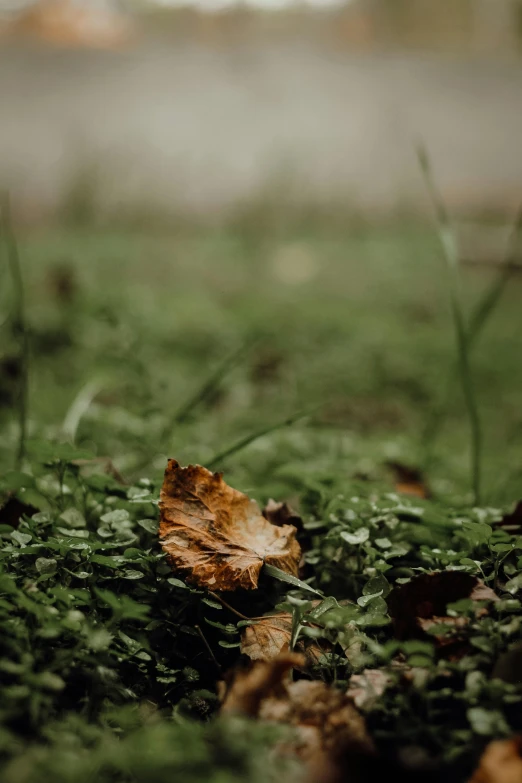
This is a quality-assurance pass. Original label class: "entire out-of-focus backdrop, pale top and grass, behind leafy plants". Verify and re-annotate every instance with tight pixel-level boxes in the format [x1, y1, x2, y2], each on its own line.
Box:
[0, 0, 522, 502]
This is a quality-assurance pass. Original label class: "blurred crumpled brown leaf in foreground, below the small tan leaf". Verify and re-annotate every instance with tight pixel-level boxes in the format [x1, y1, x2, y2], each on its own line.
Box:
[221, 653, 373, 762]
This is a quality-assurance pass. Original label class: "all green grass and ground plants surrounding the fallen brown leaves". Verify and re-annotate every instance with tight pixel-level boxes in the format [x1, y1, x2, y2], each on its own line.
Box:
[0, 224, 522, 783]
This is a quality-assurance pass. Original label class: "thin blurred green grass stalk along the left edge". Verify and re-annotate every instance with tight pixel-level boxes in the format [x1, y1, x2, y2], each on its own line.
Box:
[1, 193, 29, 468]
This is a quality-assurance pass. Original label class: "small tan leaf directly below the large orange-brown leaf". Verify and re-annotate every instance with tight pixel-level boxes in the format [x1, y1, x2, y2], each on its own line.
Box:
[241, 612, 324, 668]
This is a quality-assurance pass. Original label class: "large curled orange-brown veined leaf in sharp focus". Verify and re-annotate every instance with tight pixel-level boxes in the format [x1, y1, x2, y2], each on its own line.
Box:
[160, 459, 301, 590]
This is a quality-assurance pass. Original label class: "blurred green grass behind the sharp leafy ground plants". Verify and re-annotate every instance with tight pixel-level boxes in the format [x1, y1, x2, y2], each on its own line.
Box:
[0, 220, 522, 503]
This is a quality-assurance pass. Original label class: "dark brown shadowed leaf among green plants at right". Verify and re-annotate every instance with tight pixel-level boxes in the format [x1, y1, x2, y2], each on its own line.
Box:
[386, 571, 499, 646]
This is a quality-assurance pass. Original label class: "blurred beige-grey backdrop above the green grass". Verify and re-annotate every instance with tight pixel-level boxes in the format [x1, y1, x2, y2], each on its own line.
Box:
[0, 0, 522, 221]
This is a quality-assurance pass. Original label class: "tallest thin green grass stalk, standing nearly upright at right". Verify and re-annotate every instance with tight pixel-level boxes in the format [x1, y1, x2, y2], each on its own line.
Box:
[417, 147, 482, 505]
